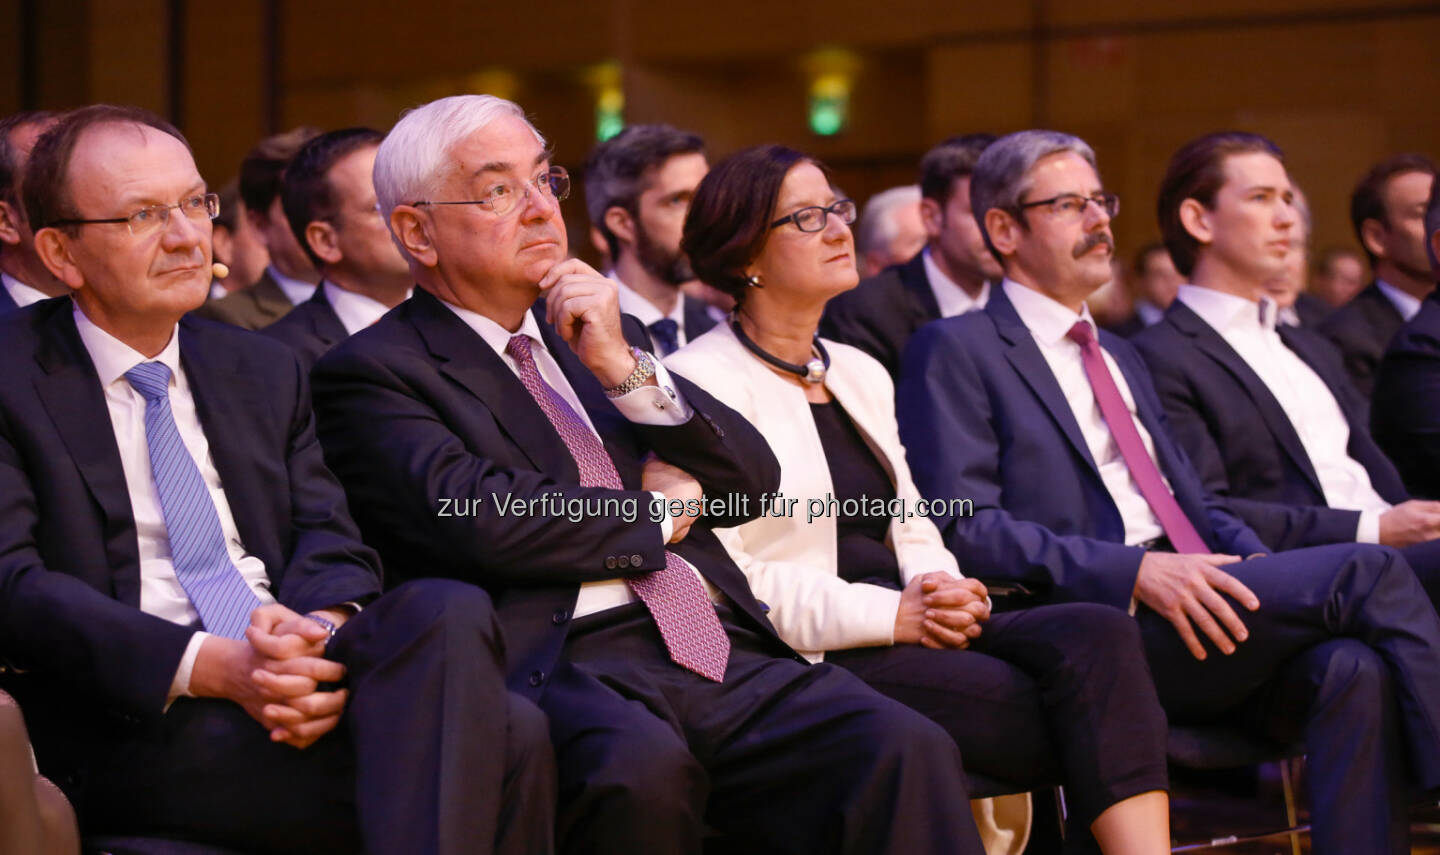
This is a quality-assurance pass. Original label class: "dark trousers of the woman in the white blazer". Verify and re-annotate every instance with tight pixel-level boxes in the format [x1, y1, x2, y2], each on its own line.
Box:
[825, 603, 1168, 829]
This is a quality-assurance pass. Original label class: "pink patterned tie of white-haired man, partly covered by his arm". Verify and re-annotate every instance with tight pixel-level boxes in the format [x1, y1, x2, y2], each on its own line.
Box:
[505, 335, 730, 682]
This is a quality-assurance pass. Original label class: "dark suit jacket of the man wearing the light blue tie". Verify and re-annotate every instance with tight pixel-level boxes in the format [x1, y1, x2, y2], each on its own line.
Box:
[0, 299, 380, 777]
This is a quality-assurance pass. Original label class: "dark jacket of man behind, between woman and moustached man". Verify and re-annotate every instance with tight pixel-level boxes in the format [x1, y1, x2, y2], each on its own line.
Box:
[819, 250, 940, 377]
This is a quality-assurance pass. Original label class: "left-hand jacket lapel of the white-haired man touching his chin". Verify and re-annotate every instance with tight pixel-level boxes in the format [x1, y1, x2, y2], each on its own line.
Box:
[409, 289, 580, 484]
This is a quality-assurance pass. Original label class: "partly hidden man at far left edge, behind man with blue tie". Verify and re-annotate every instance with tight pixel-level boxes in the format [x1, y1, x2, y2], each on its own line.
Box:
[0, 112, 69, 315]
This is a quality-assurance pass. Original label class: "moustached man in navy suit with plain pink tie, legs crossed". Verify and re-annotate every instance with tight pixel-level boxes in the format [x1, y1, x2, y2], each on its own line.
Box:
[899, 131, 1440, 854]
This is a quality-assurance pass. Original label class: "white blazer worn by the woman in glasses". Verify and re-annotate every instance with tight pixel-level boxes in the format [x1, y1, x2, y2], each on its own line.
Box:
[665, 322, 960, 662]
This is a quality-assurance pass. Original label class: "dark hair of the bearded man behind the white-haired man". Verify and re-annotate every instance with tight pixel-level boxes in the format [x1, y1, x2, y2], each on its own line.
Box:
[585, 125, 706, 258]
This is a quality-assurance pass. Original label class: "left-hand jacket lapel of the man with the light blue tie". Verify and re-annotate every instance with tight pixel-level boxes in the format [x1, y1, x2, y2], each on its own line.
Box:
[35, 299, 140, 607]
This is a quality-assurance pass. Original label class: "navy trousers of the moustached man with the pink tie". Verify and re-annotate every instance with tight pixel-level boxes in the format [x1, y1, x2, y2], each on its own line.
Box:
[1138, 544, 1440, 854]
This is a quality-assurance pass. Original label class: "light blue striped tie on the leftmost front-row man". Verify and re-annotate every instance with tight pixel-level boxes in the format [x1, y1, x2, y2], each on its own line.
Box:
[125, 363, 261, 639]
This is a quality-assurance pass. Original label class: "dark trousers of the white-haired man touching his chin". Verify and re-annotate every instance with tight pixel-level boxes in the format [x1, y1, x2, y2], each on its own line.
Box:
[540, 605, 982, 855]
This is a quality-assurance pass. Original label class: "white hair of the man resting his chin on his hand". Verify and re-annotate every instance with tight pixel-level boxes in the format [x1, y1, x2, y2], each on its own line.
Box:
[374, 95, 546, 220]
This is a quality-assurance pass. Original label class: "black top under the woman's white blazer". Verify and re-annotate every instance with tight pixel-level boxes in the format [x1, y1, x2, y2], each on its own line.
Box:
[811, 400, 900, 590]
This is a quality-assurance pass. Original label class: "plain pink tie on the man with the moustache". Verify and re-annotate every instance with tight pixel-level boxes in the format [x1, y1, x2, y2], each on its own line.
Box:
[1066, 321, 1210, 554]
